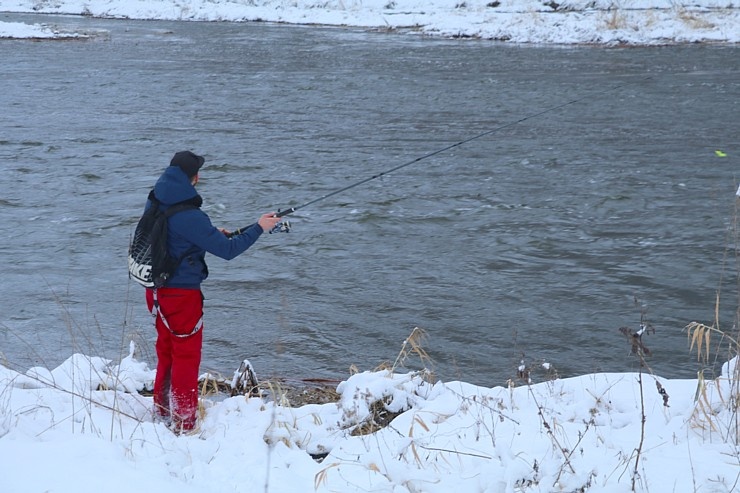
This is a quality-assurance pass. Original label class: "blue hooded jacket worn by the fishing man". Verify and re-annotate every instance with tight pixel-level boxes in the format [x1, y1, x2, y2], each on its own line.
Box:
[146, 166, 263, 289]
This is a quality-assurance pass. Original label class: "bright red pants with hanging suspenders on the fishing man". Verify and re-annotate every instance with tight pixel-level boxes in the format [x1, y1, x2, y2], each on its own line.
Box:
[146, 288, 203, 431]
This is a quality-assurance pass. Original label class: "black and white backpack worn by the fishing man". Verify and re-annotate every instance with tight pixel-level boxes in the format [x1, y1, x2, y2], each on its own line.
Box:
[128, 190, 200, 288]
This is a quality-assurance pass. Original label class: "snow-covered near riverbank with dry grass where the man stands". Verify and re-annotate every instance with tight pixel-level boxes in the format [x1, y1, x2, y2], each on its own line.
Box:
[0, 340, 740, 493]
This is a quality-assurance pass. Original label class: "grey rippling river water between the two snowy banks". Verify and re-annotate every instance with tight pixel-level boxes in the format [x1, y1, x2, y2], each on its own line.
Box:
[0, 15, 740, 386]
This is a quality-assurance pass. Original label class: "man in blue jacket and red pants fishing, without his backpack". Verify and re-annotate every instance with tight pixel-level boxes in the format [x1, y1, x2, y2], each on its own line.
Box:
[146, 151, 280, 434]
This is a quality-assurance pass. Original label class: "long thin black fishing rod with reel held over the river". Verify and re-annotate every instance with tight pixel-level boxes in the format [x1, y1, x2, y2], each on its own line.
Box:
[232, 76, 652, 235]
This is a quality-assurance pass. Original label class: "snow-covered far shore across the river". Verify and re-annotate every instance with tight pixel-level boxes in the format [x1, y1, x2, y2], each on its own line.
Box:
[0, 0, 740, 45]
